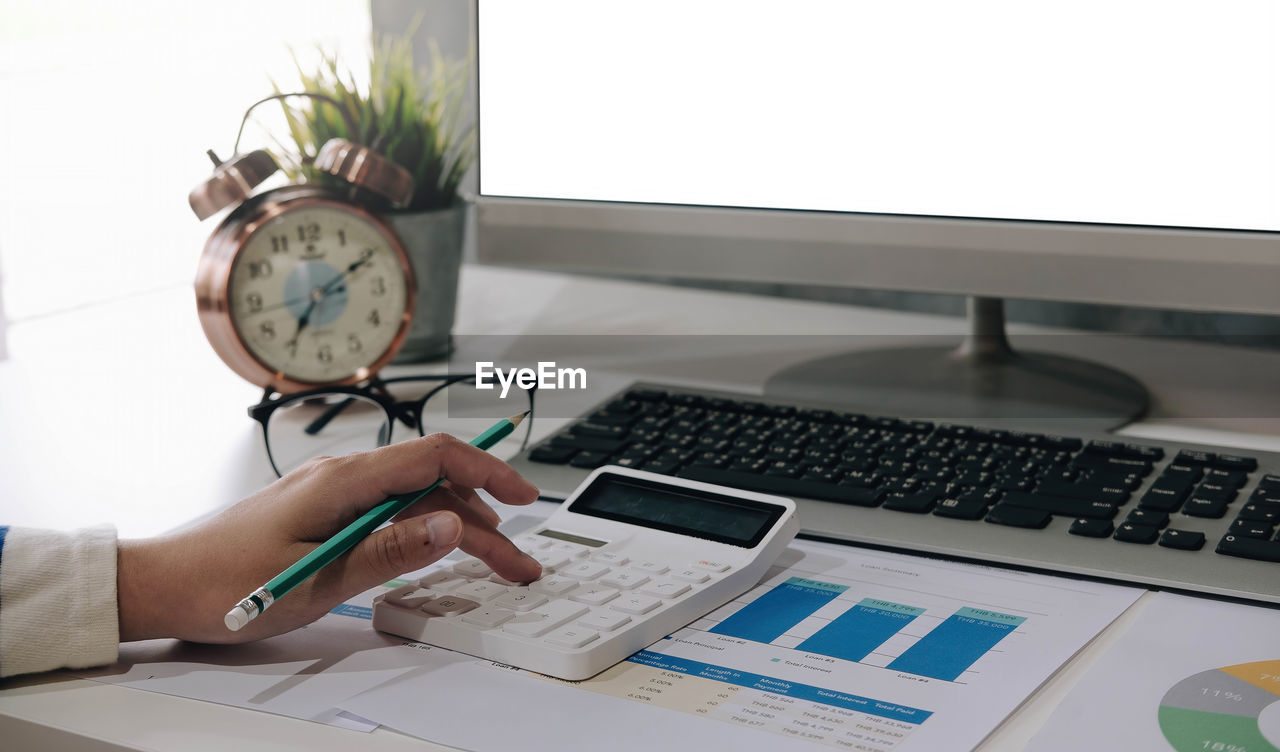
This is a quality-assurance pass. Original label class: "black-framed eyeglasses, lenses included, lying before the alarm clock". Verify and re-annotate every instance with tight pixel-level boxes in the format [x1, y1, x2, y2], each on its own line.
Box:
[248, 373, 535, 477]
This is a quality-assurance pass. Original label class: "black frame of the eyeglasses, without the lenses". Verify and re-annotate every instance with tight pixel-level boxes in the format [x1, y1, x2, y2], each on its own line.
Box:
[247, 373, 538, 478]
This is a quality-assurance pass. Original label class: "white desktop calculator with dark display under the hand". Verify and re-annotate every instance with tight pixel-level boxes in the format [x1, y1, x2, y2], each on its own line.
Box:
[374, 467, 799, 679]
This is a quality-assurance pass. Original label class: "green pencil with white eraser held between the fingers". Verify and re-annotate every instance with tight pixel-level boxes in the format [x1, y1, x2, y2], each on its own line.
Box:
[223, 412, 529, 632]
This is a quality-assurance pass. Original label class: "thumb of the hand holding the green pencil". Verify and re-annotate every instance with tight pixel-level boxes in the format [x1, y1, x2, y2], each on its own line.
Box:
[343, 512, 462, 592]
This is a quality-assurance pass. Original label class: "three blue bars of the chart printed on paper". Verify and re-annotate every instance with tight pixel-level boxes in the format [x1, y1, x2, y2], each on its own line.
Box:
[708, 577, 1027, 682]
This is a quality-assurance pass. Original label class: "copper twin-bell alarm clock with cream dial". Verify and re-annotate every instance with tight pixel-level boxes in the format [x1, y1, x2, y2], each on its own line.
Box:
[189, 139, 415, 393]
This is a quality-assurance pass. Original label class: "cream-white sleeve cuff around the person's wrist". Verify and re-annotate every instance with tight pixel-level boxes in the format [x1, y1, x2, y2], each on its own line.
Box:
[0, 526, 120, 677]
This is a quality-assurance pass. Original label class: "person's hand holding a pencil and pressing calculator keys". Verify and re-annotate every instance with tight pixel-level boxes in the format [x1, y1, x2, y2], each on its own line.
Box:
[116, 434, 541, 642]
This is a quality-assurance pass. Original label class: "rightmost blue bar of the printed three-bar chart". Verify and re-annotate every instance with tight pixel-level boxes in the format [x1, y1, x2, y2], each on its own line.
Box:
[886, 606, 1027, 682]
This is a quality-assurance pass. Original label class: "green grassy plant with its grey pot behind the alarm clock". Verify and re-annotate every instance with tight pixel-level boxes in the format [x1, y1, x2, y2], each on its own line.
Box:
[276, 37, 475, 363]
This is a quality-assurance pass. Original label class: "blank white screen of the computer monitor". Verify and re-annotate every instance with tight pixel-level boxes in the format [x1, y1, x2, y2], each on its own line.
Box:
[479, 0, 1280, 230]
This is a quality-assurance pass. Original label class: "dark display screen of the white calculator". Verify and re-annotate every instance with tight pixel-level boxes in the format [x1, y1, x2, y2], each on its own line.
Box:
[570, 473, 785, 549]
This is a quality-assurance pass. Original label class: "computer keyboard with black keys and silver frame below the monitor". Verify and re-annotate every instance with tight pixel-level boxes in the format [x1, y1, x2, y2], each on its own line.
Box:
[506, 385, 1280, 602]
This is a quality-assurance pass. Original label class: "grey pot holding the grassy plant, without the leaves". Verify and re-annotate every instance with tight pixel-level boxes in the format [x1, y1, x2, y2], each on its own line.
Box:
[387, 202, 468, 363]
